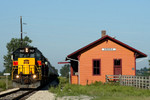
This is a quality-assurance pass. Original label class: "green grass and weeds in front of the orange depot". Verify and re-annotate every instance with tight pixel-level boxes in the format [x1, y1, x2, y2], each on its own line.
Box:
[49, 77, 150, 100]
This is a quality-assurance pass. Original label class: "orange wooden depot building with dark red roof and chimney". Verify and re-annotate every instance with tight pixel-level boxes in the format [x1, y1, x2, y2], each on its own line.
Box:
[66, 30, 147, 85]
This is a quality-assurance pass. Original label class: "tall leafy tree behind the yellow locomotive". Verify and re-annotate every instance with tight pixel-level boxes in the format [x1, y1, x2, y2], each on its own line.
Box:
[3, 36, 32, 72]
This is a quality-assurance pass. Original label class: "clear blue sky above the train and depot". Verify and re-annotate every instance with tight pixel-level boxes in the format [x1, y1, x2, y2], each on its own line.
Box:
[0, 0, 150, 70]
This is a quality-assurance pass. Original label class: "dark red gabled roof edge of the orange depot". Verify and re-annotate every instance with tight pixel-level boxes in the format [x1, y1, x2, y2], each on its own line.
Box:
[66, 35, 147, 60]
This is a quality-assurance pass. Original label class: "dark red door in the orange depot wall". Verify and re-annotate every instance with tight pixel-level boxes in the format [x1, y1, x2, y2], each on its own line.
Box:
[114, 59, 122, 75]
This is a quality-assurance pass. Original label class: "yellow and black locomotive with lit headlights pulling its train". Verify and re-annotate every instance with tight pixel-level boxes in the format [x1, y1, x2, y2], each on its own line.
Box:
[11, 47, 58, 88]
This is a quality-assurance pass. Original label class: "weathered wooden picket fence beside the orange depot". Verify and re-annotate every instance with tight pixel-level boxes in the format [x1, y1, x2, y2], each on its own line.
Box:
[106, 75, 150, 89]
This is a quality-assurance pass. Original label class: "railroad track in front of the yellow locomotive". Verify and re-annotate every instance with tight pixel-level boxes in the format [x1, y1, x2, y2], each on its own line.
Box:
[0, 89, 37, 100]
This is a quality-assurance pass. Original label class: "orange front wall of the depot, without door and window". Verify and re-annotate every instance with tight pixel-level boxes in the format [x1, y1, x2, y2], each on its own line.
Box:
[79, 40, 136, 85]
